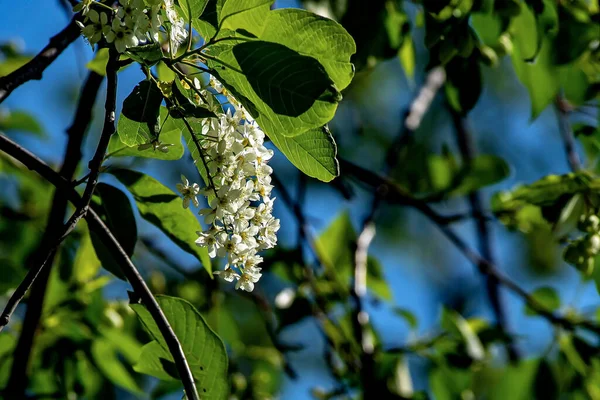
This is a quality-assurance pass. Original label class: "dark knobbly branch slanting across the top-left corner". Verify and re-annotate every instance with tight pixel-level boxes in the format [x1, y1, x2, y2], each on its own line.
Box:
[0, 14, 81, 103]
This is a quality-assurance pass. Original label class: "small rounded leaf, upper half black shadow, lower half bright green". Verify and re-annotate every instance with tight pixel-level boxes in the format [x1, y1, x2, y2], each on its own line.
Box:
[117, 80, 163, 146]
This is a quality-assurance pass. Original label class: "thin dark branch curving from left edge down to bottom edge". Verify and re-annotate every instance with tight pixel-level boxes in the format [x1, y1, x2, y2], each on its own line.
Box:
[0, 135, 199, 400]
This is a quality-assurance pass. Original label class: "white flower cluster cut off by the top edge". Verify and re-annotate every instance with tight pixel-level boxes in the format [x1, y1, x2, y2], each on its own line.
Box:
[73, 0, 188, 54]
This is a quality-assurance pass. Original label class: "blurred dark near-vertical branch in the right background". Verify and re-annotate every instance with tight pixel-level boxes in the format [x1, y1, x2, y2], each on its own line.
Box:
[449, 107, 519, 362]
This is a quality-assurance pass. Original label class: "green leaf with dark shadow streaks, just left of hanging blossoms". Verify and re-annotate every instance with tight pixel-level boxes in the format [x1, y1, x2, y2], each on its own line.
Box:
[111, 169, 212, 275]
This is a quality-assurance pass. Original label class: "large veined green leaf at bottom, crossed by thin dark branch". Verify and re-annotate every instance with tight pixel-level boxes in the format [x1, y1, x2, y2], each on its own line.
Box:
[131, 296, 229, 399]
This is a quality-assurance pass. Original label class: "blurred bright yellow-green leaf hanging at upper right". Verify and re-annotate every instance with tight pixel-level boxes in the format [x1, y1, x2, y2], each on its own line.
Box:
[511, 6, 560, 120]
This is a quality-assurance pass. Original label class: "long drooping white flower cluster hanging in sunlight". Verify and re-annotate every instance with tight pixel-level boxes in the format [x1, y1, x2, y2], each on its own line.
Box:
[177, 77, 279, 292]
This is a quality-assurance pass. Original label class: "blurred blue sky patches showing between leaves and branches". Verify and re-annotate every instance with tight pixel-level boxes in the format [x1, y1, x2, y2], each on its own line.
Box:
[0, 0, 599, 399]
